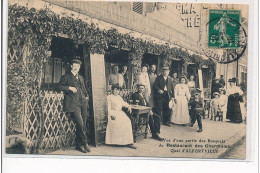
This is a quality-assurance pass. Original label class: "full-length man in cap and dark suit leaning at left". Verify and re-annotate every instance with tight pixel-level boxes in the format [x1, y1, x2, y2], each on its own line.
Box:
[57, 59, 90, 153]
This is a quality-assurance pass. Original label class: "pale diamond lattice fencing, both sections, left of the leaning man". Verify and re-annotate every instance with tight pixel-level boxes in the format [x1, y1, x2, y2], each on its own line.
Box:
[24, 90, 76, 152]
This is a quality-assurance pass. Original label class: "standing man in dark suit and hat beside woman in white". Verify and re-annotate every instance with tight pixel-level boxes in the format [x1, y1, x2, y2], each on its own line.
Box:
[153, 67, 174, 126]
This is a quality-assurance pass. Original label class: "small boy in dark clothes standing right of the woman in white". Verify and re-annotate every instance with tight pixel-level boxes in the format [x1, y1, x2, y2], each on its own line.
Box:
[190, 88, 204, 132]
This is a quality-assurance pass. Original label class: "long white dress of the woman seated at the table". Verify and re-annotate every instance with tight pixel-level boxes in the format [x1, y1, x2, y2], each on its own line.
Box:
[105, 95, 133, 145]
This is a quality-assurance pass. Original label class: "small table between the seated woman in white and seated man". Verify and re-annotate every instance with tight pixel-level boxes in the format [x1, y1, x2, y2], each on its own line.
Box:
[130, 105, 152, 142]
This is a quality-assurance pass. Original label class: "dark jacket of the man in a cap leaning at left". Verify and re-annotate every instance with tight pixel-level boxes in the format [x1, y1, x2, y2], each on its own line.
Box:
[57, 72, 88, 112]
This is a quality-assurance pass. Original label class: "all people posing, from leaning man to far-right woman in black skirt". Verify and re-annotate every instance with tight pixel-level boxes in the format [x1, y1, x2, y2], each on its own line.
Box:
[57, 59, 246, 153]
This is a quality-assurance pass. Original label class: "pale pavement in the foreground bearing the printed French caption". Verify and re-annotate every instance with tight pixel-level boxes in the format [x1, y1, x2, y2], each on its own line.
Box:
[49, 119, 246, 159]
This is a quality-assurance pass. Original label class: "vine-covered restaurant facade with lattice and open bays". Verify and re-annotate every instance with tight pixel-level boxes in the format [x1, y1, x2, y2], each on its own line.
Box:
[6, 0, 216, 153]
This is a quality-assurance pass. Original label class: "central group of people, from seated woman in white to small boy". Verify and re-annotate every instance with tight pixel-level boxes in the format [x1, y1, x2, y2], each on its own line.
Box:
[105, 65, 203, 148]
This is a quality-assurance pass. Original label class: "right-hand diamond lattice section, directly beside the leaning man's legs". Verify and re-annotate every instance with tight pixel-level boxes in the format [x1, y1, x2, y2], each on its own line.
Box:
[40, 91, 76, 150]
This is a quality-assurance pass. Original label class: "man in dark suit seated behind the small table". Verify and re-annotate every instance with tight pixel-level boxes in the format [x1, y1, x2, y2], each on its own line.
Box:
[131, 83, 163, 141]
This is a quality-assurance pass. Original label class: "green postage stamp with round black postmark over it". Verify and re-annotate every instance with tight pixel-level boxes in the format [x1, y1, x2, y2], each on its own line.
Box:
[203, 10, 247, 64]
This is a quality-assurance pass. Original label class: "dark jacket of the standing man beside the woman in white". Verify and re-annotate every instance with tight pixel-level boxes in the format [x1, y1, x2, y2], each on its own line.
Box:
[153, 75, 174, 99]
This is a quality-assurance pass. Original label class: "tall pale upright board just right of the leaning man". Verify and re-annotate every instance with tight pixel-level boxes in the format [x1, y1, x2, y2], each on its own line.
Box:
[90, 54, 107, 145]
